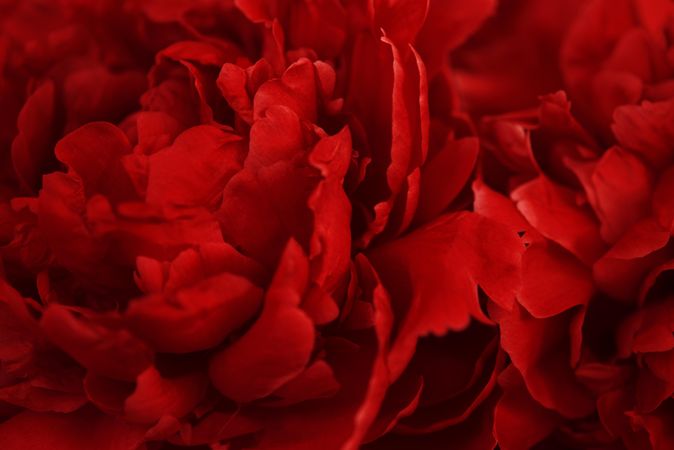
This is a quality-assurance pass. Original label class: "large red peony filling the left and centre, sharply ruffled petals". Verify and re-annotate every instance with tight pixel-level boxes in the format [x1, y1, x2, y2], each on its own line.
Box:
[0, 1, 523, 449]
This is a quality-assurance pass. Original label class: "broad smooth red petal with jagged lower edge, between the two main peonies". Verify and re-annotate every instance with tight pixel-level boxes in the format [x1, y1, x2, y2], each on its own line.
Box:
[370, 213, 524, 374]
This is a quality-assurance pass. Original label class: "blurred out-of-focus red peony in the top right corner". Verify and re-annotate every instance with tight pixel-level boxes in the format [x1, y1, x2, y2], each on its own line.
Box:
[561, 0, 674, 141]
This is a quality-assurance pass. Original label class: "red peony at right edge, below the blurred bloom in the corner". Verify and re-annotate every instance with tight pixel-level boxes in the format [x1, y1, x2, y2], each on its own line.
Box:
[473, 22, 674, 449]
